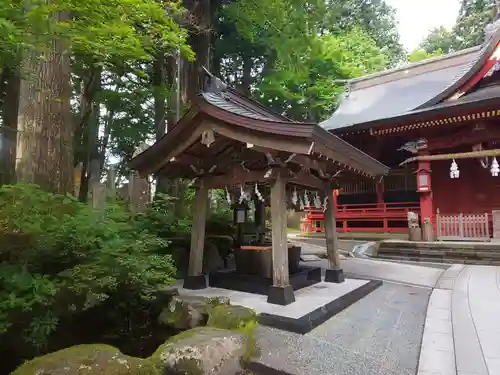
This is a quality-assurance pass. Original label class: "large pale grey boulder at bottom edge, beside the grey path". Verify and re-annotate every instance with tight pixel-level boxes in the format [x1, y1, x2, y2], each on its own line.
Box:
[152, 327, 248, 375]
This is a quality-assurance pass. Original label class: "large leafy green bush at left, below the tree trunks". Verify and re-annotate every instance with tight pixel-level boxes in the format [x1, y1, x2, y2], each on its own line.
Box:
[0, 184, 175, 347]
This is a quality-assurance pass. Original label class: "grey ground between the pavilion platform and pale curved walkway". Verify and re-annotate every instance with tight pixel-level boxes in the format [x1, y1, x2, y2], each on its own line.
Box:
[257, 283, 431, 375]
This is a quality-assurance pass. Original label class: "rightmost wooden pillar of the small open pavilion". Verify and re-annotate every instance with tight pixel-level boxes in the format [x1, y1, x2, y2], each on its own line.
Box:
[325, 185, 345, 283]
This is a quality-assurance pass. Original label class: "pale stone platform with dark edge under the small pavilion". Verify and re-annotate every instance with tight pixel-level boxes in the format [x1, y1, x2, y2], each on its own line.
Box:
[176, 279, 382, 334]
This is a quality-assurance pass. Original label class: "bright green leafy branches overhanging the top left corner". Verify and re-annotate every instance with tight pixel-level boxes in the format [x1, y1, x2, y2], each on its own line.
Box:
[0, 0, 192, 65]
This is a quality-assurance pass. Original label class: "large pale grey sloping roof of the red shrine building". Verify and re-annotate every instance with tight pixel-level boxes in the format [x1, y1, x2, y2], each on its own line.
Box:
[320, 22, 500, 131]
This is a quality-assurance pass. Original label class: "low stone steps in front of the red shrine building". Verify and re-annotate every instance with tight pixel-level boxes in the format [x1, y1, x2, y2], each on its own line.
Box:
[374, 240, 500, 265]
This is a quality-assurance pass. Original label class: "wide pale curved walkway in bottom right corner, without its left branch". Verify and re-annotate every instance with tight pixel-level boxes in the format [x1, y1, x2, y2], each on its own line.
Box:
[418, 265, 500, 375]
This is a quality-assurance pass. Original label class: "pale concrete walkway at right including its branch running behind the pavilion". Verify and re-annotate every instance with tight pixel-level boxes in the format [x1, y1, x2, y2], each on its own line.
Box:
[295, 239, 500, 375]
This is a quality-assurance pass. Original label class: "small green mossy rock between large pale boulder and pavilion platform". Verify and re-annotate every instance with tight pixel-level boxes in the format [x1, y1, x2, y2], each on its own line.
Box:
[207, 304, 257, 329]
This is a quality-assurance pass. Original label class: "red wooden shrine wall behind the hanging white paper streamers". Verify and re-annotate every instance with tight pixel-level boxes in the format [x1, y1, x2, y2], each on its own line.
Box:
[431, 159, 500, 214]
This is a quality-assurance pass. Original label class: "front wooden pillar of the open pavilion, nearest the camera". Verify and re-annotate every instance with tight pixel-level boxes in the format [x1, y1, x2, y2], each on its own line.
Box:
[267, 172, 295, 305]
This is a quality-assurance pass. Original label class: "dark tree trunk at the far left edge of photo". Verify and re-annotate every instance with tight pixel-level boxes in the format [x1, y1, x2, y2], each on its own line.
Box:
[0, 67, 21, 184]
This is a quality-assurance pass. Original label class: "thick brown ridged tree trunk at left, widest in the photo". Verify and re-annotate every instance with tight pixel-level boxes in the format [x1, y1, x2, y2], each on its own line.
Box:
[16, 13, 74, 193]
